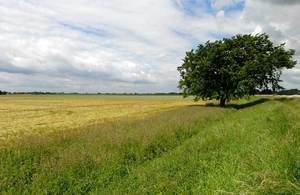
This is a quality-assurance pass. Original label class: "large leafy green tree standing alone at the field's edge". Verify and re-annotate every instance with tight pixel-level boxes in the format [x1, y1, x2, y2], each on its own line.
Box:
[178, 34, 296, 106]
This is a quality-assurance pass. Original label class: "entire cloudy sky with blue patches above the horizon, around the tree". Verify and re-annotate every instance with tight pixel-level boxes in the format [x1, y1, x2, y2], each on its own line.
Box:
[0, 0, 300, 93]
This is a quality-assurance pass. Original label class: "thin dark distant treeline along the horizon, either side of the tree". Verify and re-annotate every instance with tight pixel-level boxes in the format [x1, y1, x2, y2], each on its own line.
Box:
[0, 89, 300, 95]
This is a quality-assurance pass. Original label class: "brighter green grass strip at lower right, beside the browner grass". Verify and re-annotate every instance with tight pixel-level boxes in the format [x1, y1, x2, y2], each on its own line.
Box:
[105, 98, 300, 194]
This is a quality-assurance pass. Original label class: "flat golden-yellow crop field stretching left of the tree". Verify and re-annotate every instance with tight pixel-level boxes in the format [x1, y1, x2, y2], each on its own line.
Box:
[0, 95, 201, 140]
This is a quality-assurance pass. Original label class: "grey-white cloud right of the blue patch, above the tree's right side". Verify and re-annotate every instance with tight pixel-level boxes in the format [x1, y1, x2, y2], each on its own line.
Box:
[243, 0, 300, 88]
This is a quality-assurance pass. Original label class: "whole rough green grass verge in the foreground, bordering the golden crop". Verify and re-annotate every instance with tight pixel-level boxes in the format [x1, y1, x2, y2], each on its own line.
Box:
[0, 99, 300, 194]
